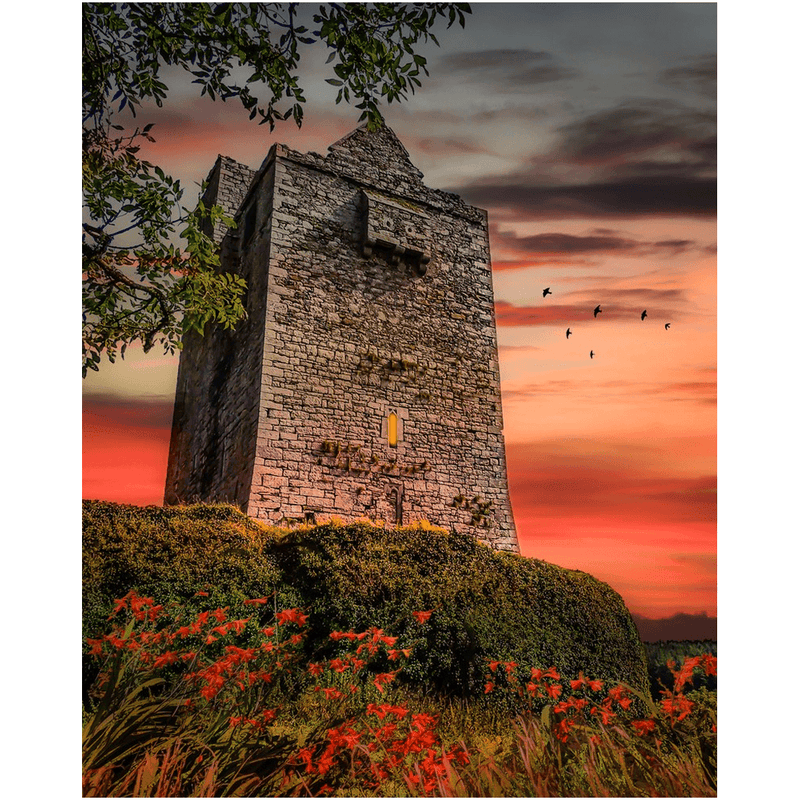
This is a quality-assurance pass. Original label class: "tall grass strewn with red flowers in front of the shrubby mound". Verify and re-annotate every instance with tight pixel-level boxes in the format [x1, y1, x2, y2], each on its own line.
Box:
[83, 592, 716, 797]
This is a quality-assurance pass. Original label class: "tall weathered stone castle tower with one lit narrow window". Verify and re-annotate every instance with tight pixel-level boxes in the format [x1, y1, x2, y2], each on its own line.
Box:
[165, 126, 519, 552]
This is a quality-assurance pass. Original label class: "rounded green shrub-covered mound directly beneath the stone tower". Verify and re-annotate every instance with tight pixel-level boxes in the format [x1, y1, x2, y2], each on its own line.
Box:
[83, 501, 648, 695]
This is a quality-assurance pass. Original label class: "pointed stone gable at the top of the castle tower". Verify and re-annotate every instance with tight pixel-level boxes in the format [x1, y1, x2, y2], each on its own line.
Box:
[326, 123, 422, 182]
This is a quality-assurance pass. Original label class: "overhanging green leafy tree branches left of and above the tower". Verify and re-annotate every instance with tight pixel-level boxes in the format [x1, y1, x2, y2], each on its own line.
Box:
[82, 3, 470, 376]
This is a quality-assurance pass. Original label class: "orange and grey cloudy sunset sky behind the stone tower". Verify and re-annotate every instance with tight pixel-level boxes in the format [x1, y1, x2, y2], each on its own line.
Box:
[83, 3, 717, 638]
